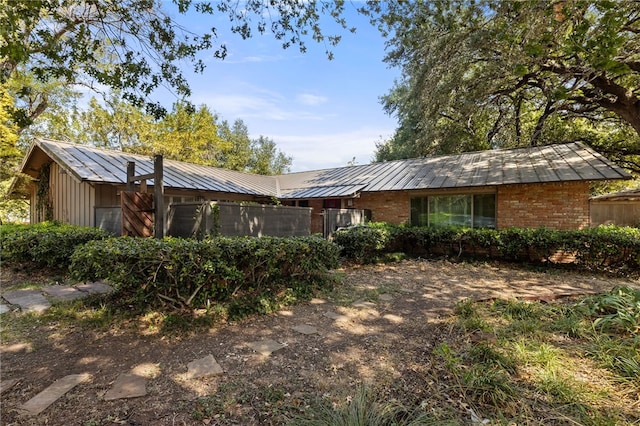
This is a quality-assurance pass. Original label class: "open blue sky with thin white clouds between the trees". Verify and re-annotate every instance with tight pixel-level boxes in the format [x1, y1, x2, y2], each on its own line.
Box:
[162, 2, 399, 172]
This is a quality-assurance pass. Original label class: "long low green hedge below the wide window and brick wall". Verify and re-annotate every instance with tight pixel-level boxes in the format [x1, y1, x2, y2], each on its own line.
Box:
[334, 223, 640, 270]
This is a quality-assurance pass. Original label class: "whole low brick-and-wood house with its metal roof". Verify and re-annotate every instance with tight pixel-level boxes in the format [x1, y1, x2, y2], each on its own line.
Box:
[13, 139, 631, 233]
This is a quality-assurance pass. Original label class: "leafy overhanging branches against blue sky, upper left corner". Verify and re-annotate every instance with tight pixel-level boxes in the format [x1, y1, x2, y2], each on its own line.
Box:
[0, 0, 353, 130]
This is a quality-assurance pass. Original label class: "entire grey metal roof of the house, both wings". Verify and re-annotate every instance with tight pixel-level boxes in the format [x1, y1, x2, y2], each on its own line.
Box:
[22, 139, 631, 199]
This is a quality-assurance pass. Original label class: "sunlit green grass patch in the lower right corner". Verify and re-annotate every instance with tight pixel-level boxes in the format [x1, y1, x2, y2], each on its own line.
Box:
[434, 288, 640, 425]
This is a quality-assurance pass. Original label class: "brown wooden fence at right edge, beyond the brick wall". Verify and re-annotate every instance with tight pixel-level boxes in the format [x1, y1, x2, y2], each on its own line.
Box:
[591, 189, 640, 227]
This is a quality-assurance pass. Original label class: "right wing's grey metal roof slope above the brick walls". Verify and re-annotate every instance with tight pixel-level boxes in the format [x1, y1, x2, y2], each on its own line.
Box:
[279, 142, 631, 197]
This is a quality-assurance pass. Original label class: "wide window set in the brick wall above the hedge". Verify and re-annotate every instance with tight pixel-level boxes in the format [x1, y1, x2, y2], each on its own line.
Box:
[411, 194, 496, 228]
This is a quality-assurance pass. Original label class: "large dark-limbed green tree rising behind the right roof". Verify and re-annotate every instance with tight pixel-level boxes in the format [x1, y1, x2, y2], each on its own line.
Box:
[377, 0, 640, 171]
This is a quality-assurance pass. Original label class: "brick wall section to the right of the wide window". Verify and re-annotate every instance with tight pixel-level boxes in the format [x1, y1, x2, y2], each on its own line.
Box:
[496, 181, 589, 229]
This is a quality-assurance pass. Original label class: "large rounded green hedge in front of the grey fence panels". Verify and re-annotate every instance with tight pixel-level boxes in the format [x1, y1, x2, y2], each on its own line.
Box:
[70, 237, 340, 310]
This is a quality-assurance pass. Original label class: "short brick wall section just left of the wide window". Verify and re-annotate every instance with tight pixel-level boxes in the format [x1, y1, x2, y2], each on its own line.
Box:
[353, 191, 411, 225]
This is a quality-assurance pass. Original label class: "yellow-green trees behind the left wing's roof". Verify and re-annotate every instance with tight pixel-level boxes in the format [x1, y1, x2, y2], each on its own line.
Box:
[28, 93, 291, 174]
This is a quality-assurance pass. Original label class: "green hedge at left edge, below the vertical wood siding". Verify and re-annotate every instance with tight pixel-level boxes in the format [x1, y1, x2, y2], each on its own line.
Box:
[0, 222, 110, 269]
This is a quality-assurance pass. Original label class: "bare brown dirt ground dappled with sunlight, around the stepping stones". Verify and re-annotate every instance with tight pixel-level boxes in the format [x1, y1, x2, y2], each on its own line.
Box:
[0, 260, 640, 425]
